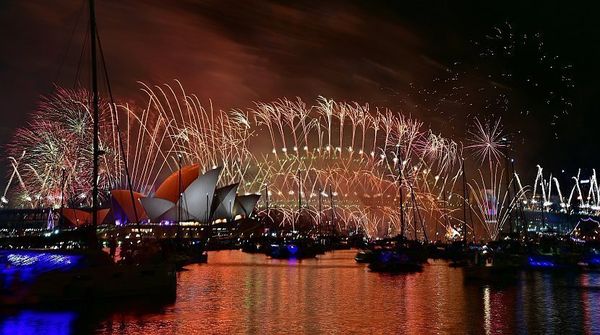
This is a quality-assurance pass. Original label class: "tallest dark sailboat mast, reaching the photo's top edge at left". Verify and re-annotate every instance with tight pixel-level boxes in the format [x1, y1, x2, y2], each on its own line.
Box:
[89, 0, 100, 230]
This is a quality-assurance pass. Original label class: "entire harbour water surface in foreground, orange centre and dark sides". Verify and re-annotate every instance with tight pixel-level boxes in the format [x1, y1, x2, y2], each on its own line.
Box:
[0, 251, 600, 335]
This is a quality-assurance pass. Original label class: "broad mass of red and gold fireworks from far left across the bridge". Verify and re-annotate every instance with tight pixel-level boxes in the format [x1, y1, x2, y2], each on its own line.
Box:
[4, 82, 458, 237]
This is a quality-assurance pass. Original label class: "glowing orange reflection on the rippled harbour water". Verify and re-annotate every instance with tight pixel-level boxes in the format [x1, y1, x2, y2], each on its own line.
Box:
[100, 251, 476, 334]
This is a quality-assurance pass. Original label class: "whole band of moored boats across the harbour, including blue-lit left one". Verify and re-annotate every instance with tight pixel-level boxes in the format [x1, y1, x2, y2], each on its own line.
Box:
[0, 215, 600, 305]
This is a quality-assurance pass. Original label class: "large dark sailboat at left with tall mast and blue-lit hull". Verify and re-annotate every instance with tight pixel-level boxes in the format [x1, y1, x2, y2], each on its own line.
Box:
[0, 0, 177, 305]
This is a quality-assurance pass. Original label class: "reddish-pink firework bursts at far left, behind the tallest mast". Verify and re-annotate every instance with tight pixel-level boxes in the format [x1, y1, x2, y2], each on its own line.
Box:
[5, 88, 123, 207]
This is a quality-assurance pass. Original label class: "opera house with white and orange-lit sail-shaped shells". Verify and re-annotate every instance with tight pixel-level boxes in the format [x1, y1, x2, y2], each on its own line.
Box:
[125, 165, 260, 223]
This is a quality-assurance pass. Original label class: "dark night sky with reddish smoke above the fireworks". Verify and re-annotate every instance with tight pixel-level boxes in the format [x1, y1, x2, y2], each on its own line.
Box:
[0, 0, 600, 185]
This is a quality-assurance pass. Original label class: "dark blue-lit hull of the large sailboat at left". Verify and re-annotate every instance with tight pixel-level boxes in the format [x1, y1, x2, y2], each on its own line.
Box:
[0, 250, 177, 306]
